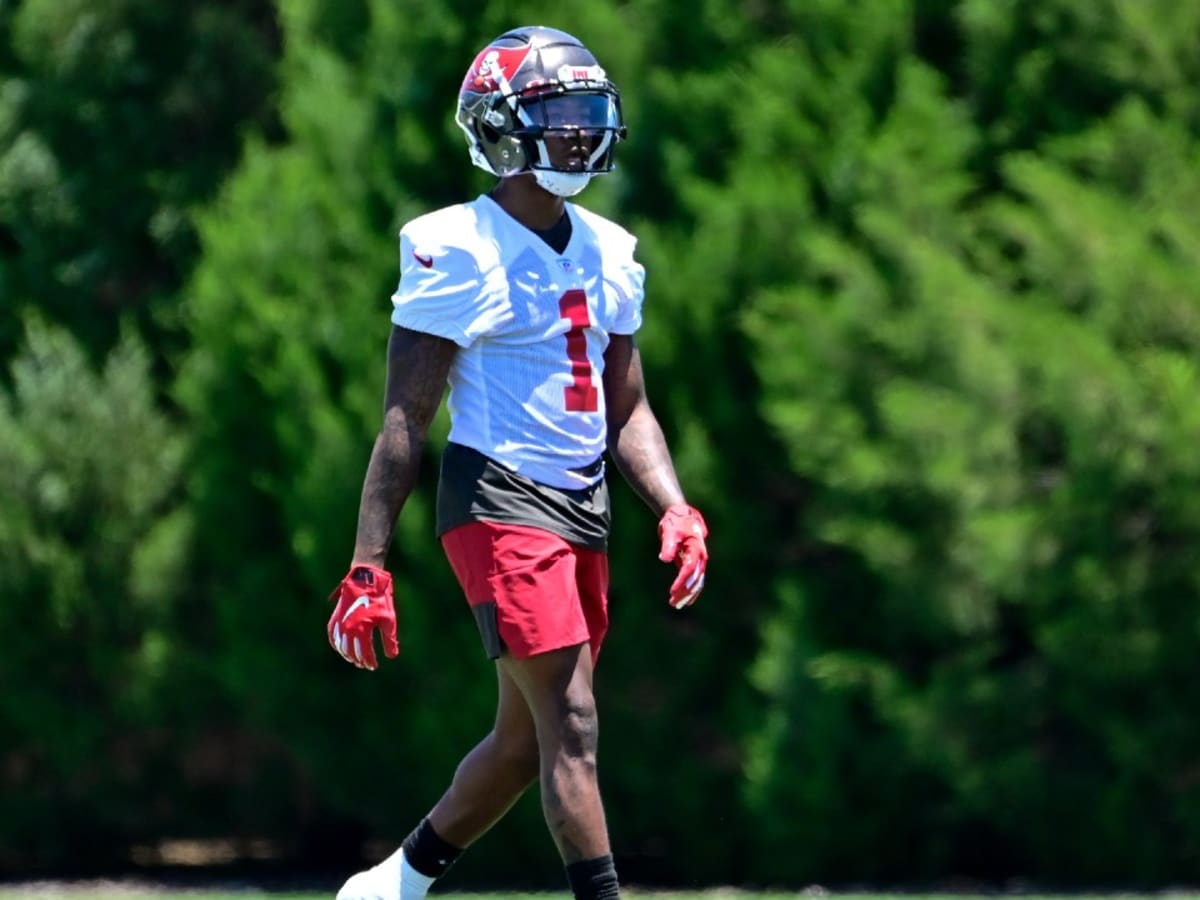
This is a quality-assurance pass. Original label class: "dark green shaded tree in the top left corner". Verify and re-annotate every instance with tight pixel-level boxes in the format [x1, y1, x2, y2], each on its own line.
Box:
[0, 0, 276, 359]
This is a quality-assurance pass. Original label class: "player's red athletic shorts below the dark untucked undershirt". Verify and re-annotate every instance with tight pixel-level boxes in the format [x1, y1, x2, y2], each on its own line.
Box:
[442, 522, 608, 661]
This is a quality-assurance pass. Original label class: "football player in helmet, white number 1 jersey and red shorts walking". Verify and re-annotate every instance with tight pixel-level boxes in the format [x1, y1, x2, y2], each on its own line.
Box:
[328, 26, 708, 900]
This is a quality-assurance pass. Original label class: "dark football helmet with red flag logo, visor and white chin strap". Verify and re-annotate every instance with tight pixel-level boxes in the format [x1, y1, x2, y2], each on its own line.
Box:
[455, 26, 625, 197]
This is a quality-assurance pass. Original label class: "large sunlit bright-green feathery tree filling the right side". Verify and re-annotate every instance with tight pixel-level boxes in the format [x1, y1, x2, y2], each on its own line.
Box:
[746, 2, 1200, 883]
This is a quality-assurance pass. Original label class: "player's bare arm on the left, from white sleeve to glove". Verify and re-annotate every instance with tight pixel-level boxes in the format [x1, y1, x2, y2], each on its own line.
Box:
[352, 326, 458, 569]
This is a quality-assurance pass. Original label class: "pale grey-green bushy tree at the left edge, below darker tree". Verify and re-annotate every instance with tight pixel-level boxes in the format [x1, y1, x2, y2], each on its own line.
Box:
[0, 319, 191, 864]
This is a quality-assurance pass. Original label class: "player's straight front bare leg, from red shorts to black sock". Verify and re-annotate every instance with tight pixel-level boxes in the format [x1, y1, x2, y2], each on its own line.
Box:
[499, 643, 610, 865]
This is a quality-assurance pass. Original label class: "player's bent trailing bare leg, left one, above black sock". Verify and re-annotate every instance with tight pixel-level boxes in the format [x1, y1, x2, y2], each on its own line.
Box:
[428, 665, 538, 847]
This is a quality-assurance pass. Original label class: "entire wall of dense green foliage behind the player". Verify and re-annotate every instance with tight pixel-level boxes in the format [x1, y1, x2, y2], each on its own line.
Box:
[0, 0, 1200, 887]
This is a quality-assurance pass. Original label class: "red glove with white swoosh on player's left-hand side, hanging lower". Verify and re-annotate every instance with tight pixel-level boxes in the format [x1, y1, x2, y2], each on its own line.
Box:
[325, 565, 400, 668]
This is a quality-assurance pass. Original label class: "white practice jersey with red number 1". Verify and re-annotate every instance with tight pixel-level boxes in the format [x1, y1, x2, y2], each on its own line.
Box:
[391, 194, 644, 488]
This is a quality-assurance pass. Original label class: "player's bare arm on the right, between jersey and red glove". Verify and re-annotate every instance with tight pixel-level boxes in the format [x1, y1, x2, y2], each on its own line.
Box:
[604, 335, 685, 516]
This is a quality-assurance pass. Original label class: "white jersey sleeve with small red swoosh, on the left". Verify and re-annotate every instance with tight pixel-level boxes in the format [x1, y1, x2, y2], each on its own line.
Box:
[391, 227, 506, 347]
